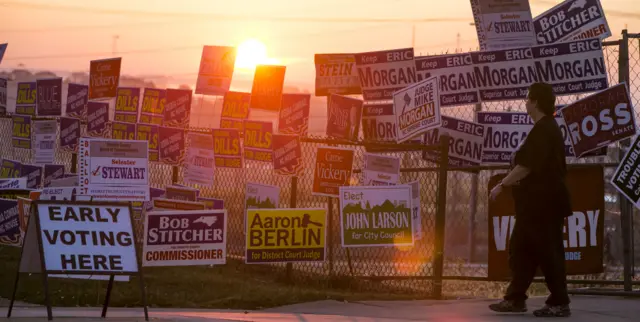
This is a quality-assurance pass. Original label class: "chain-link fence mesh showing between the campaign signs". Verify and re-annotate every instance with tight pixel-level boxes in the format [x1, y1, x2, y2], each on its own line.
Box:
[0, 33, 640, 296]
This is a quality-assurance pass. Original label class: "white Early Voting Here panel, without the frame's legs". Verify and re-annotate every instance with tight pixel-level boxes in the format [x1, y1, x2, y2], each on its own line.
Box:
[34, 201, 138, 274]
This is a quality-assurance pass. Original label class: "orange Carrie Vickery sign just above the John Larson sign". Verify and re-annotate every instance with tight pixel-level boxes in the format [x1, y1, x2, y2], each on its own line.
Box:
[311, 147, 355, 197]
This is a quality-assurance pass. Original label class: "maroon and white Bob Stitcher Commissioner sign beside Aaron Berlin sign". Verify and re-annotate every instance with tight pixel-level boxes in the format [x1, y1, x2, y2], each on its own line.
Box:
[142, 210, 227, 266]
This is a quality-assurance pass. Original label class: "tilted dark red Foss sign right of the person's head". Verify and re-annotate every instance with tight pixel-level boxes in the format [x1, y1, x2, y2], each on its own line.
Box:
[560, 83, 636, 158]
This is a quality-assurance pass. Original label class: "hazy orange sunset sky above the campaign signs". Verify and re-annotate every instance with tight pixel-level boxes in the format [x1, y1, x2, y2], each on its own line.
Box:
[0, 0, 640, 90]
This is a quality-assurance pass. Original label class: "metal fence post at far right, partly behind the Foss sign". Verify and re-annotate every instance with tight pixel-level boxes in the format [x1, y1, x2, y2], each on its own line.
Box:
[618, 29, 635, 292]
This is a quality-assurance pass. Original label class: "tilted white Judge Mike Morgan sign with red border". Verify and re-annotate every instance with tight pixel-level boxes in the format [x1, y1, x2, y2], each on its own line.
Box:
[393, 77, 441, 143]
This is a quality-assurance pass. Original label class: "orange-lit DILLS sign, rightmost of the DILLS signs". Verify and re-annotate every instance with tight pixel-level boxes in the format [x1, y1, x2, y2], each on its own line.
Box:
[243, 120, 273, 163]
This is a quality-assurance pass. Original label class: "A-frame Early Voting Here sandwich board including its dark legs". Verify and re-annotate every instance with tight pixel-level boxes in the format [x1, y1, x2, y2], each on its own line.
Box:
[7, 200, 148, 320]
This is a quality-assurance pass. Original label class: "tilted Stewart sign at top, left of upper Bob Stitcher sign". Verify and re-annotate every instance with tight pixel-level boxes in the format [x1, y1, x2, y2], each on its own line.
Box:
[471, 0, 536, 51]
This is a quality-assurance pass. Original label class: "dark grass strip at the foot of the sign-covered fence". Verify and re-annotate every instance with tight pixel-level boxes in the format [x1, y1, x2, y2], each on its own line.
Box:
[0, 246, 427, 310]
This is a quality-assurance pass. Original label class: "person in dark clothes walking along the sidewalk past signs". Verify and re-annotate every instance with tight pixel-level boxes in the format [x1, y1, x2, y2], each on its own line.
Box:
[489, 83, 572, 317]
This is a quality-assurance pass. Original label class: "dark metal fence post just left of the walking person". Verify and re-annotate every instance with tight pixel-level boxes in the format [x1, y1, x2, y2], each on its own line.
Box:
[433, 135, 450, 299]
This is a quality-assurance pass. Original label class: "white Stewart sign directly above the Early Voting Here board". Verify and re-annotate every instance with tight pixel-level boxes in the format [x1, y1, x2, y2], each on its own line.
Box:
[79, 138, 149, 201]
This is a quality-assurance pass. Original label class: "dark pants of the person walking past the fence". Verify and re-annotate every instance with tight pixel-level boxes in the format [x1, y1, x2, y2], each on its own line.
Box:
[504, 213, 570, 306]
